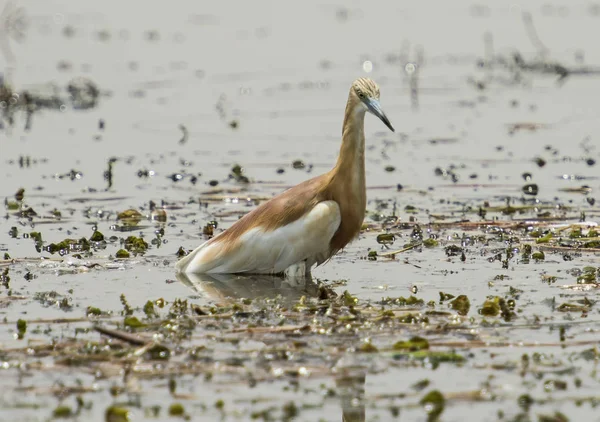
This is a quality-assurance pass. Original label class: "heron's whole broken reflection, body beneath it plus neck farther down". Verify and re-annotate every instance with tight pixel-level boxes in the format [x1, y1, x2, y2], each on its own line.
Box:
[177, 273, 366, 422]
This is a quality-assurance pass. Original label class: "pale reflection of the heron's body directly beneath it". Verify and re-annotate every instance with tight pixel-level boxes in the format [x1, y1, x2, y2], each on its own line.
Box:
[177, 273, 325, 302]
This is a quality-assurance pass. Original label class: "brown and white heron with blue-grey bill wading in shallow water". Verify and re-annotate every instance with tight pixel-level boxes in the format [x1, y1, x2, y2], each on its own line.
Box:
[175, 78, 394, 278]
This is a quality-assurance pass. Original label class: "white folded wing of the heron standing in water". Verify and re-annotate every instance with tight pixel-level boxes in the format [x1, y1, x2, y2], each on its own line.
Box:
[176, 201, 341, 274]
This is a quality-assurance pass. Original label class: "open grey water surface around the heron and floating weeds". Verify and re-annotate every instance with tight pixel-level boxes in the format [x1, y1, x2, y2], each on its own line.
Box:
[0, 1, 600, 421]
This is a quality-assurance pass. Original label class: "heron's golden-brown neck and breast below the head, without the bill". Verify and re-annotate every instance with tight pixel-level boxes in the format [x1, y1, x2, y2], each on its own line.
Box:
[327, 91, 366, 250]
